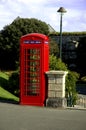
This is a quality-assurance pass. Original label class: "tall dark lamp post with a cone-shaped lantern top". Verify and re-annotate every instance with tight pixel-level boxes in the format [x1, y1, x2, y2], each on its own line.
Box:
[57, 7, 67, 60]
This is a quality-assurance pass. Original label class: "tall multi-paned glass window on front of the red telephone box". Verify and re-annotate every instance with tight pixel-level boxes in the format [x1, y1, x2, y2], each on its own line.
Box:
[24, 49, 40, 96]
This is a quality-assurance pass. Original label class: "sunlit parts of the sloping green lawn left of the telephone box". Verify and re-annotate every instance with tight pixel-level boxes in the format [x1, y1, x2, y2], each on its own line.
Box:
[0, 72, 19, 102]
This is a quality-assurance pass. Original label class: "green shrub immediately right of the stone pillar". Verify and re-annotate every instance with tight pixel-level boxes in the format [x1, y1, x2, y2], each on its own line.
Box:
[66, 71, 79, 106]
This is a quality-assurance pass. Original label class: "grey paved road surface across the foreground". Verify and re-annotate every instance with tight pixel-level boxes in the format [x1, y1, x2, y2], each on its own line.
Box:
[0, 103, 86, 130]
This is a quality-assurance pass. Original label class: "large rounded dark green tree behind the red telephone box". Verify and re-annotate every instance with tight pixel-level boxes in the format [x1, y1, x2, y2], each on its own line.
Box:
[0, 17, 49, 69]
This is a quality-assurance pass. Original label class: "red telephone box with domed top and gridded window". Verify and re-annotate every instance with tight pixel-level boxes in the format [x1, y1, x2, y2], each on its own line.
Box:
[20, 33, 49, 106]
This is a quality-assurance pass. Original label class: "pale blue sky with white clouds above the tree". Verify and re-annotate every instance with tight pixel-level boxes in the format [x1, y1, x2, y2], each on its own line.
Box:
[0, 0, 86, 32]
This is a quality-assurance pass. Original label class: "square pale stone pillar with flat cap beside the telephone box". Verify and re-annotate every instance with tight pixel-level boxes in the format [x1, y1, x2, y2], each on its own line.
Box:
[46, 71, 67, 107]
